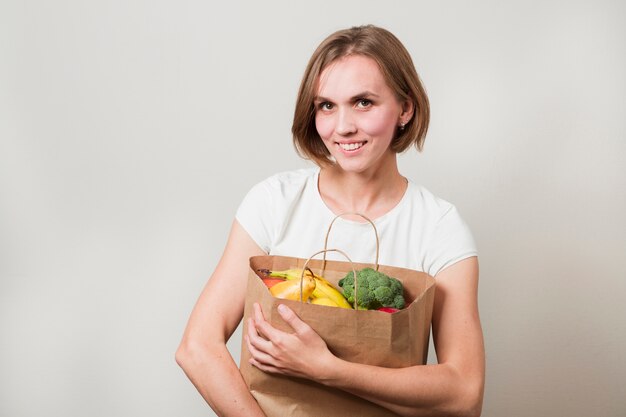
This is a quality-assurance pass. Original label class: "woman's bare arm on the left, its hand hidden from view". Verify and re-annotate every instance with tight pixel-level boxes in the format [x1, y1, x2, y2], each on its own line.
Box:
[176, 221, 265, 417]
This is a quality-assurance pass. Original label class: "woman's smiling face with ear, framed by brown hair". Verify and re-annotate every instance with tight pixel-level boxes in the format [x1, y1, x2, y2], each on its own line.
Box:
[314, 55, 412, 173]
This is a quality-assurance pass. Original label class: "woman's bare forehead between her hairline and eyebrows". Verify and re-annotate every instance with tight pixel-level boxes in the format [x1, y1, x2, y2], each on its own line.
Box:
[316, 55, 391, 97]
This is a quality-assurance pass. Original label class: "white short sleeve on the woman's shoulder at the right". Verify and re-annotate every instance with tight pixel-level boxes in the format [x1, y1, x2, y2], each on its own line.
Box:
[426, 205, 478, 277]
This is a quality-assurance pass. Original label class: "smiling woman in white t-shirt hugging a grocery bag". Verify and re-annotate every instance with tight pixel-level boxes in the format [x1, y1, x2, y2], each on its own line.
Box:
[176, 26, 484, 416]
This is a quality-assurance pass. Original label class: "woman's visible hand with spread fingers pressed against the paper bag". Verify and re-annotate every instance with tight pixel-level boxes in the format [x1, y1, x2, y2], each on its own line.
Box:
[246, 303, 336, 381]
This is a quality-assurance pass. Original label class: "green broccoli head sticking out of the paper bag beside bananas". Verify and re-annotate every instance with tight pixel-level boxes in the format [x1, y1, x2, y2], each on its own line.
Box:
[339, 268, 404, 310]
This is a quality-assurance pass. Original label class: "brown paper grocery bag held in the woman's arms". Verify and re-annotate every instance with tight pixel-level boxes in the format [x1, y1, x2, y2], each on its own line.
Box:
[240, 250, 435, 417]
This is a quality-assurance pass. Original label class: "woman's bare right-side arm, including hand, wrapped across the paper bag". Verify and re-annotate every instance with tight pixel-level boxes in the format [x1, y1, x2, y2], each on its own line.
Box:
[246, 258, 485, 416]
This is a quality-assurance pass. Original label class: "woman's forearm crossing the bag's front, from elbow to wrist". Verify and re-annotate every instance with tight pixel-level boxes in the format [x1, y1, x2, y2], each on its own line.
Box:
[320, 359, 483, 416]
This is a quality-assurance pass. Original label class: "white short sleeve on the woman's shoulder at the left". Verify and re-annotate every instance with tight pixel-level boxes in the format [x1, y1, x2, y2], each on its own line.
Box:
[235, 181, 276, 253]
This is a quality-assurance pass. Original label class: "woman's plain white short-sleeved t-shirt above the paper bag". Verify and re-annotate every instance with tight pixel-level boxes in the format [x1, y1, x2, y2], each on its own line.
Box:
[236, 168, 477, 276]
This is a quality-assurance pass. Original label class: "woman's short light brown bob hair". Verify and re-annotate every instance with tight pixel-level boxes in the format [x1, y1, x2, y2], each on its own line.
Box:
[291, 25, 430, 166]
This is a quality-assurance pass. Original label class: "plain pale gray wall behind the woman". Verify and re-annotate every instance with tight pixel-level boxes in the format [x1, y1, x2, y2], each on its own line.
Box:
[0, 0, 626, 417]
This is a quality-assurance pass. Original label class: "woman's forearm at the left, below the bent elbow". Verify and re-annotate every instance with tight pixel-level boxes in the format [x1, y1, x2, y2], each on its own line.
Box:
[176, 343, 265, 417]
